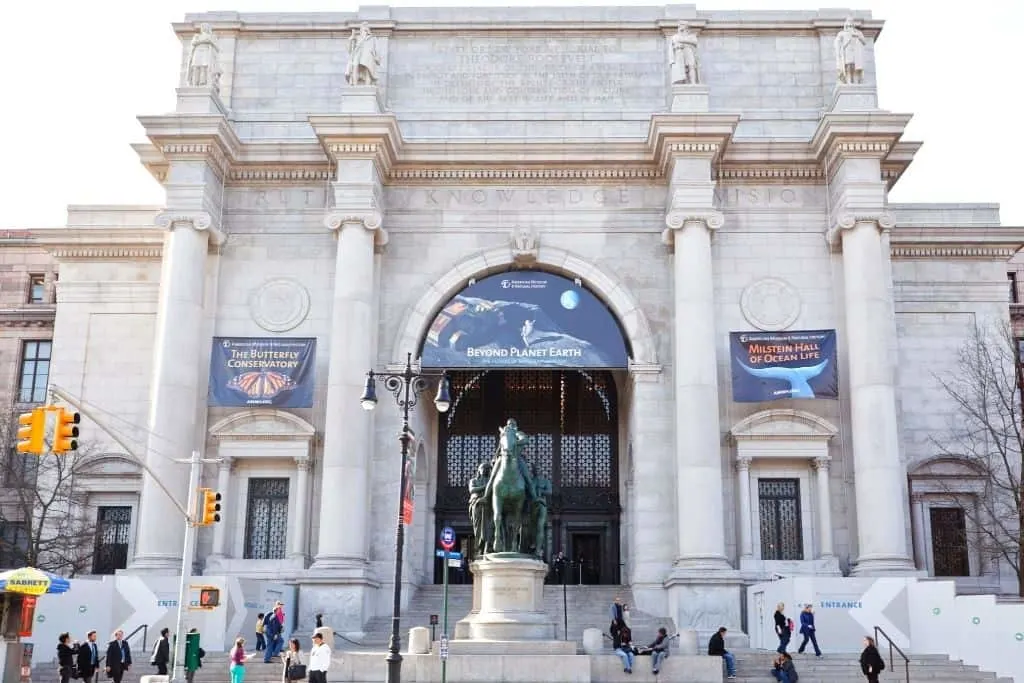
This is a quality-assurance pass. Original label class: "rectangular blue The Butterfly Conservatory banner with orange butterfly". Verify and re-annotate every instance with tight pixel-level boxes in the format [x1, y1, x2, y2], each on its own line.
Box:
[210, 337, 316, 408]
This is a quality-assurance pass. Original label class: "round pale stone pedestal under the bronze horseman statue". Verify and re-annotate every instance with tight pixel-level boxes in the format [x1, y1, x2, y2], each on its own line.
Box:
[455, 553, 555, 641]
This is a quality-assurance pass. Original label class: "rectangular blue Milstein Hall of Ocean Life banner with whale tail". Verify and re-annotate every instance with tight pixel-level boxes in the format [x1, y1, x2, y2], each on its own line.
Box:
[729, 330, 839, 403]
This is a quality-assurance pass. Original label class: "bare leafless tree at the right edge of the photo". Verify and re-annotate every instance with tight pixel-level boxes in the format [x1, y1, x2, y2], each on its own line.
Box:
[934, 323, 1024, 595]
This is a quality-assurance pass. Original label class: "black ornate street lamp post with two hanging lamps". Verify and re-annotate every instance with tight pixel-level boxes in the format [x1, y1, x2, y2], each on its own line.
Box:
[359, 353, 452, 683]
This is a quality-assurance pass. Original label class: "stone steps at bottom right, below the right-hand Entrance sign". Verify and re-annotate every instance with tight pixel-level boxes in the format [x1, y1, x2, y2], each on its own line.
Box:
[722, 650, 1013, 683]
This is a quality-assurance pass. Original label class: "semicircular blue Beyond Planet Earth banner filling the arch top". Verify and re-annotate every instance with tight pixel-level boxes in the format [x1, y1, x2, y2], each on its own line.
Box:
[421, 270, 629, 369]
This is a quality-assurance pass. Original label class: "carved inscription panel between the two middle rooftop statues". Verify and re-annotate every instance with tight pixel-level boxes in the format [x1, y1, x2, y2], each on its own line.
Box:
[387, 34, 666, 112]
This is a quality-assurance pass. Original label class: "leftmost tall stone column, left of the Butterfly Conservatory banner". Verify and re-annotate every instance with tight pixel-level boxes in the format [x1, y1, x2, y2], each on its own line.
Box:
[129, 211, 223, 573]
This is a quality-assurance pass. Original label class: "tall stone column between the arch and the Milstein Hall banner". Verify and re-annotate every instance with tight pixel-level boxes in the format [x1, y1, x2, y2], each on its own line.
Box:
[666, 211, 730, 570]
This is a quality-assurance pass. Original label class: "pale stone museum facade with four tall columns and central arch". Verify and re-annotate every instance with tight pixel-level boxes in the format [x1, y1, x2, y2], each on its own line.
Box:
[25, 6, 1024, 630]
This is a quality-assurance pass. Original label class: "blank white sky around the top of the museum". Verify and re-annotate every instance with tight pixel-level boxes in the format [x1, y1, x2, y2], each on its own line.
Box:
[0, 0, 1024, 228]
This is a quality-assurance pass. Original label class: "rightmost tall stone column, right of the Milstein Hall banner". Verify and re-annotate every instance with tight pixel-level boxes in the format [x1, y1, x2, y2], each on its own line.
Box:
[833, 212, 912, 574]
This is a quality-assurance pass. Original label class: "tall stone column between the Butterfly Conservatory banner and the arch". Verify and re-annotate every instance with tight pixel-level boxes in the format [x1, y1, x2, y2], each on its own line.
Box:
[313, 212, 384, 572]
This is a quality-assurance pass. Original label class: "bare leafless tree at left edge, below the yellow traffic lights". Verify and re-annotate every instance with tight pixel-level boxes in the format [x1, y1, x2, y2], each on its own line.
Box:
[0, 411, 96, 577]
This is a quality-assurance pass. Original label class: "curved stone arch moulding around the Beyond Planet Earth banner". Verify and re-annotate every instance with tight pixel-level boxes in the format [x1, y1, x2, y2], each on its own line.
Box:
[391, 246, 657, 366]
